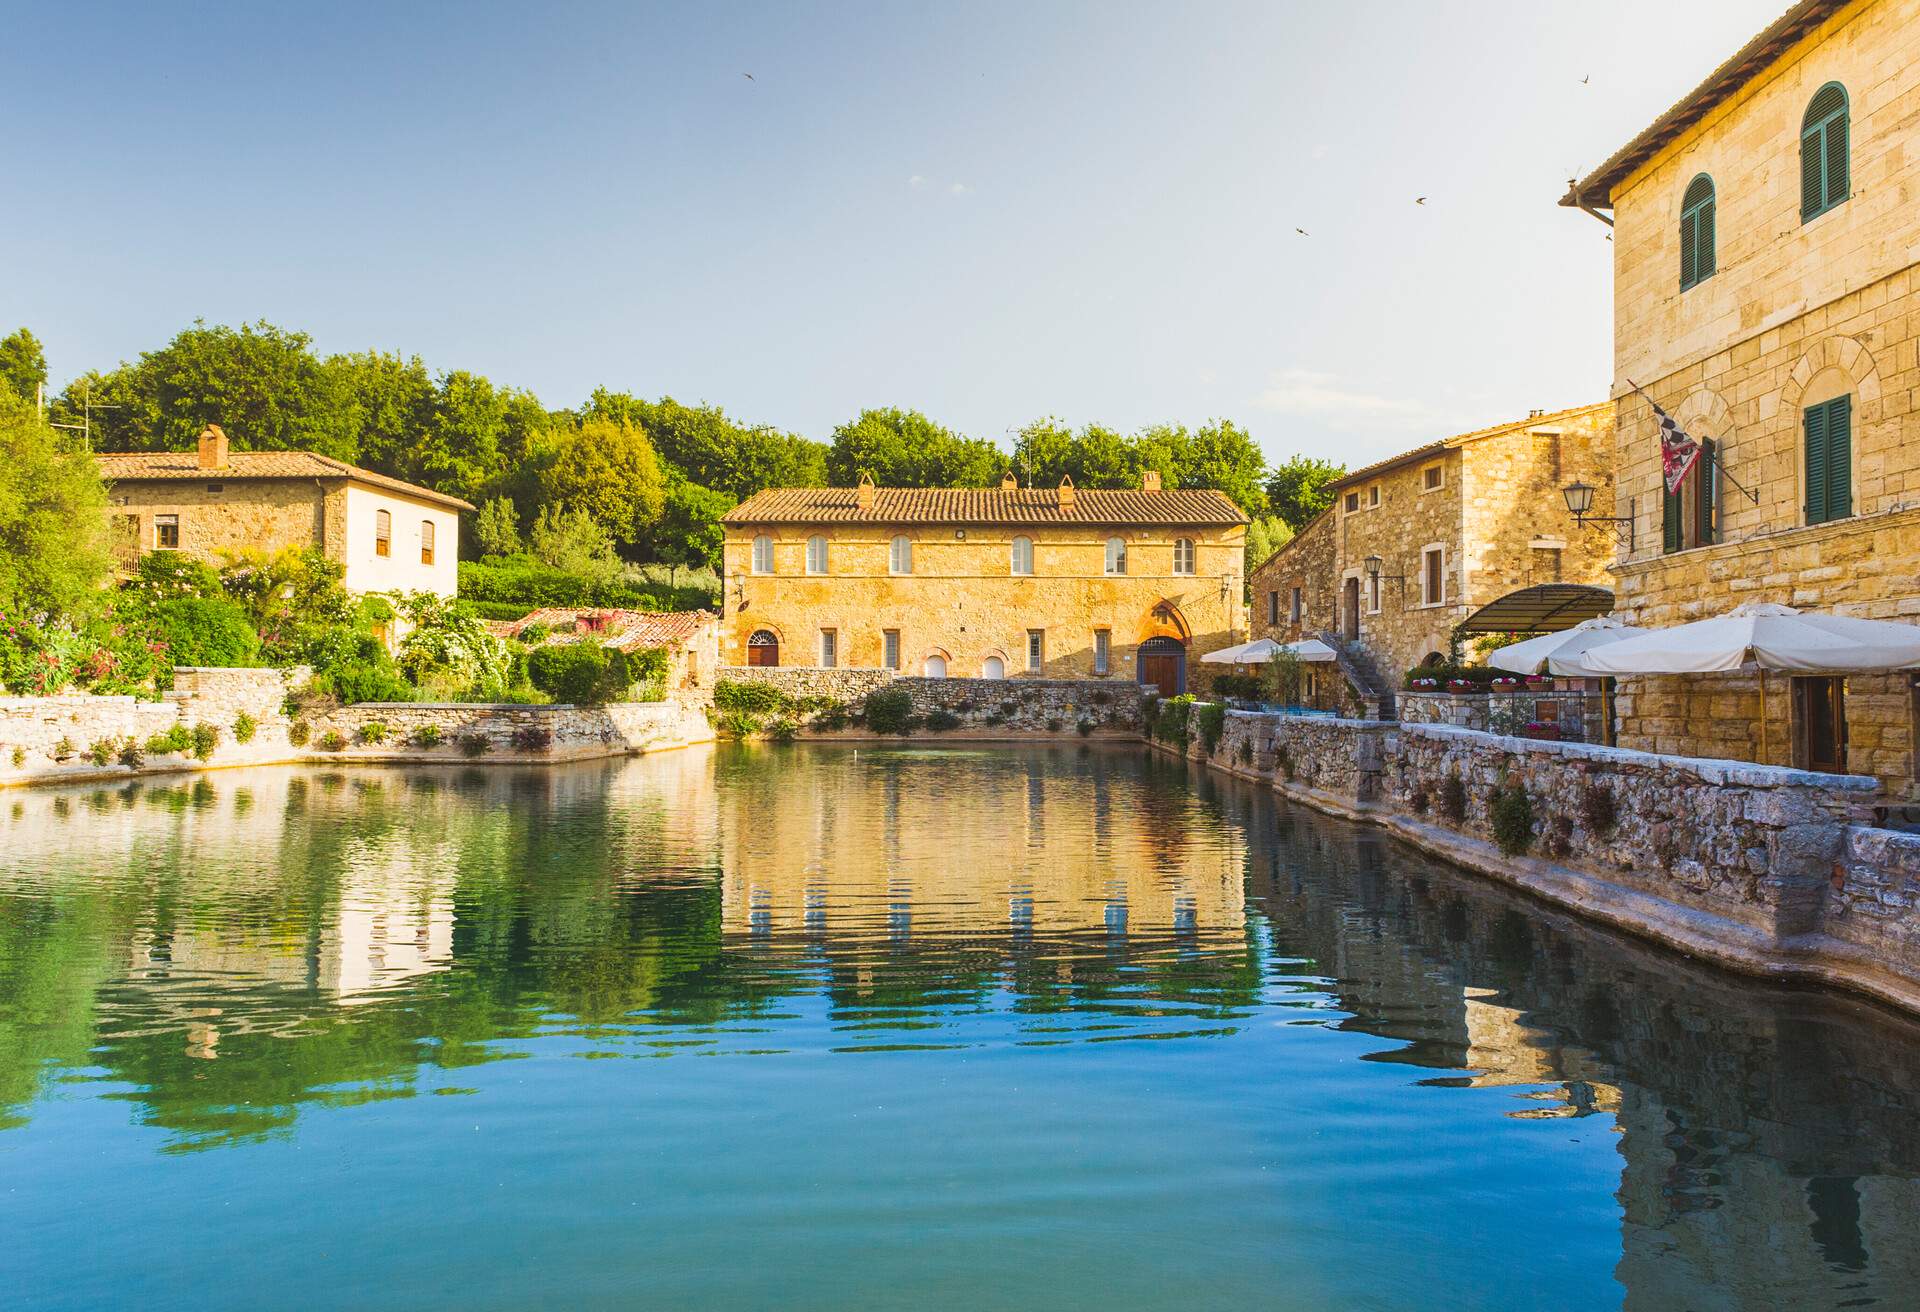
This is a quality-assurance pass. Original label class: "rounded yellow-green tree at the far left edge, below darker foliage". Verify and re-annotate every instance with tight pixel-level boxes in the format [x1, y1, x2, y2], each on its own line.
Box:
[0, 398, 113, 617]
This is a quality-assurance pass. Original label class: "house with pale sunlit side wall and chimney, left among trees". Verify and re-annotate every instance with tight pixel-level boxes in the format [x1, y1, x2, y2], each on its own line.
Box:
[96, 425, 472, 597]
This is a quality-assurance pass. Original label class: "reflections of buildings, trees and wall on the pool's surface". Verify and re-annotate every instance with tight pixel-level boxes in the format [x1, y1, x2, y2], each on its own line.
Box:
[0, 747, 1920, 1308]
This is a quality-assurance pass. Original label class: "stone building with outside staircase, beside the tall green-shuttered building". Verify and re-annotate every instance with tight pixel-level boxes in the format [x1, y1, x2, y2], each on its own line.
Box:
[1252, 401, 1613, 701]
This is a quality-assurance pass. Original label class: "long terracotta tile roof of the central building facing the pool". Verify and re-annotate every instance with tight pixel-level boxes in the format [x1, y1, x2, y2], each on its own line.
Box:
[720, 488, 1246, 526]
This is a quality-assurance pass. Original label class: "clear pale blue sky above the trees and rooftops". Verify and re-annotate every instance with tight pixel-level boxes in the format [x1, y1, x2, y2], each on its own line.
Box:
[11, 0, 1784, 465]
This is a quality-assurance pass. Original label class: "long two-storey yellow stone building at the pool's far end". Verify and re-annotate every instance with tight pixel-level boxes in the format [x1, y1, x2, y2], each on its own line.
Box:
[720, 473, 1246, 693]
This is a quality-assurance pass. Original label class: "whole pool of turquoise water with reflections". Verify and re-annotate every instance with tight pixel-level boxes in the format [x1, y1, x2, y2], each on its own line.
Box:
[0, 745, 1920, 1310]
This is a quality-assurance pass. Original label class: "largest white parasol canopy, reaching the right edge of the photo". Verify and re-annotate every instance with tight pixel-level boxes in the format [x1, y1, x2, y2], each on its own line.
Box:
[1580, 601, 1920, 674]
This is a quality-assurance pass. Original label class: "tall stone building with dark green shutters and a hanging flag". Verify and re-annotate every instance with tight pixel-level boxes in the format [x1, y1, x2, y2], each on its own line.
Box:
[1561, 0, 1920, 793]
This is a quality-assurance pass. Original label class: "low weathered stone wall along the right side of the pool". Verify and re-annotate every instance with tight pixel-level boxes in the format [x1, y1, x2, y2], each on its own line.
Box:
[1159, 711, 1920, 1010]
